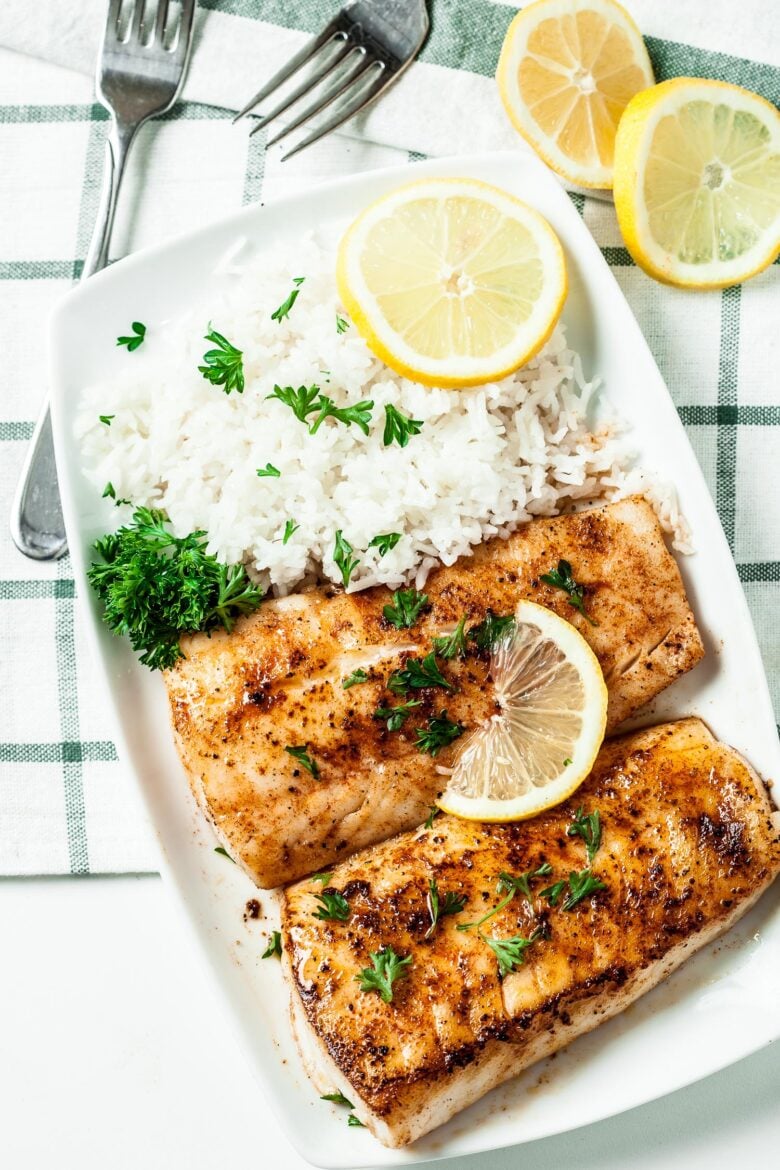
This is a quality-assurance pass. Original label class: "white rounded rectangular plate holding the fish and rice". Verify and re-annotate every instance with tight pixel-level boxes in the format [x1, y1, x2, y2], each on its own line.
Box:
[51, 153, 780, 1166]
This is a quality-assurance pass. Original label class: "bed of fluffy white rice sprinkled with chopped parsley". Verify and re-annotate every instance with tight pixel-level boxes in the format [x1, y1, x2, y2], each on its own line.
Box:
[76, 236, 688, 594]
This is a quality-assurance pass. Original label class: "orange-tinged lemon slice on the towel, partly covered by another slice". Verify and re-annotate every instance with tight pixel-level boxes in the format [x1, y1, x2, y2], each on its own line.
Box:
[496, 0, 655, 187]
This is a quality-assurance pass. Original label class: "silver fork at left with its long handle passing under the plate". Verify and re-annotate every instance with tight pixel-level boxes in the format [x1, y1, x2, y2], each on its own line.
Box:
[11, 0, 195, 560]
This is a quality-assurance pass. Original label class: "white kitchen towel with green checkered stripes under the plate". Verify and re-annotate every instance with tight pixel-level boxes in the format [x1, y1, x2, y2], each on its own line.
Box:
[0, 0, 780, 874]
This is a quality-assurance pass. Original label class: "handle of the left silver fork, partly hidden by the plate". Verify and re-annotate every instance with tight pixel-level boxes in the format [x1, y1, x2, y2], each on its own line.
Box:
[11, 122, 138, 560]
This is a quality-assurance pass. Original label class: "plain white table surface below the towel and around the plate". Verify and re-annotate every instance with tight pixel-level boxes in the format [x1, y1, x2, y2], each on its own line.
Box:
[0, 876, 780, 1170]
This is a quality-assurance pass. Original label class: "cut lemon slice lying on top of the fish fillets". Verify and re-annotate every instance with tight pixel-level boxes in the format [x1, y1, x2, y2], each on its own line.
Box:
[437, 601, 607, 821]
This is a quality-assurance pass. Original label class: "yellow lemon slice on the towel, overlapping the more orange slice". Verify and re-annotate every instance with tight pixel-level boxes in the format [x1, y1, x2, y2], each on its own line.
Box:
[615, 77, 780, 288]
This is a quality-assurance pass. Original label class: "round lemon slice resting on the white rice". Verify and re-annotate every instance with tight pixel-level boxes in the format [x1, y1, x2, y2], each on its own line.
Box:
[337, 179, 566, 387]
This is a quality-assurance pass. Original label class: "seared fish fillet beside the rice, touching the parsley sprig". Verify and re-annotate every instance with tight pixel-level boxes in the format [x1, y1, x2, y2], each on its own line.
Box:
[166, 498, 703, 887]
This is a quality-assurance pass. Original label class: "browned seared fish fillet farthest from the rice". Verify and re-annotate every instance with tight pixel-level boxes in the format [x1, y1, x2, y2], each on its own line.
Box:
[282, 718, 780, 1147]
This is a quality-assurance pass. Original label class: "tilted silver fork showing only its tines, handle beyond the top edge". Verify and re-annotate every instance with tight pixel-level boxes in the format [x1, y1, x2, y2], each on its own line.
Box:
[234, 0, 429, 159]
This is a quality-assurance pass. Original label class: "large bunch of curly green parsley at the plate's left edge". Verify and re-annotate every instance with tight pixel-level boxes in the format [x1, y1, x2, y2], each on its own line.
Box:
[87, 508, 263, 670]
